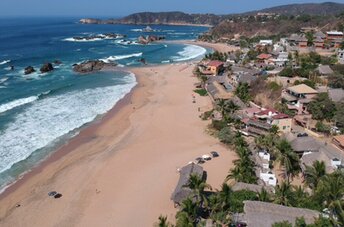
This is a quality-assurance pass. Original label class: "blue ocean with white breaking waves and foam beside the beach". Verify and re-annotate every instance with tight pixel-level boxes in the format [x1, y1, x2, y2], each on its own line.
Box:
[0, 18, 208, 191]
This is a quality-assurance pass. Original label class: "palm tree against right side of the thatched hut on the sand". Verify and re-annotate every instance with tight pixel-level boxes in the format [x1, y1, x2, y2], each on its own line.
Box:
[186, 174, 211, 207]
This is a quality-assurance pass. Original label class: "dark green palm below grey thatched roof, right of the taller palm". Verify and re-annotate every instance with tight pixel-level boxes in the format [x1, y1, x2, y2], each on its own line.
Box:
[305, 160, 326, 189]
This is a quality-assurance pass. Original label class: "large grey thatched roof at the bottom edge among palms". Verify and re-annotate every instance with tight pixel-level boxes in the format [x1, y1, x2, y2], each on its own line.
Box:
[241, 201, 320, 227]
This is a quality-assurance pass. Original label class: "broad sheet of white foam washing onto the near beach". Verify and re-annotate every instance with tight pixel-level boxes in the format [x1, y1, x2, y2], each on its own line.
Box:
[0, 74, 136, 172]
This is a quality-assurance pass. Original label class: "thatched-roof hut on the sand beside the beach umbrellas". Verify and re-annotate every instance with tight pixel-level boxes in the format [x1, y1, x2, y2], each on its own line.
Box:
[171, 163, 206, 205]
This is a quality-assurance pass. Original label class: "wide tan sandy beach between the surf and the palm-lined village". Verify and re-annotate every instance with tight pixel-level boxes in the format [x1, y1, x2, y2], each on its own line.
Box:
[0, 55, 235, 226]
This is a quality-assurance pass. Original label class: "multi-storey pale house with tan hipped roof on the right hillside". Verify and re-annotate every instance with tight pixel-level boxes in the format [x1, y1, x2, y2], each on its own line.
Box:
[282, 84, 318, 114]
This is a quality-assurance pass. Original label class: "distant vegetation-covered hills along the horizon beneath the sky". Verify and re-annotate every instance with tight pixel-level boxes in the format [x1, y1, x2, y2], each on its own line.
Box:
[80, 2, 344, 28]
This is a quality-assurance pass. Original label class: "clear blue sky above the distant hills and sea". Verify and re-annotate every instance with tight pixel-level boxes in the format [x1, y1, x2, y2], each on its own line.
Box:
[0, 0, 344, 18]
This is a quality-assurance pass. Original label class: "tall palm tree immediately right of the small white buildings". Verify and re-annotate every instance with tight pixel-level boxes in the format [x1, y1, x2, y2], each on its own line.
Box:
[276, 139, 300, 180]
